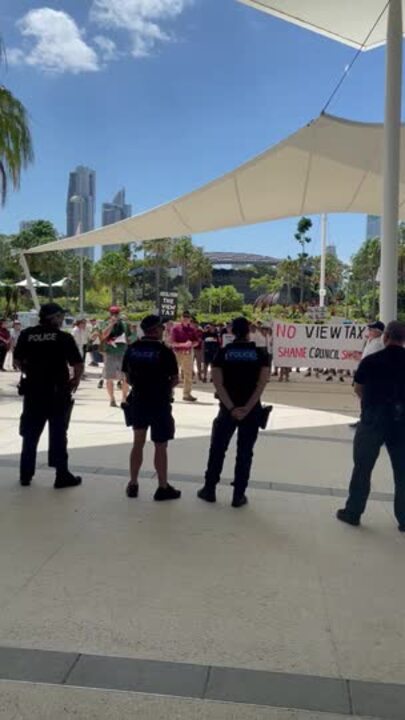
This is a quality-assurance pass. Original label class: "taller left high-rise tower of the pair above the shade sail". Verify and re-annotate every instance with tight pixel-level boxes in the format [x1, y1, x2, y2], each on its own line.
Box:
[66, 165, 96, 260]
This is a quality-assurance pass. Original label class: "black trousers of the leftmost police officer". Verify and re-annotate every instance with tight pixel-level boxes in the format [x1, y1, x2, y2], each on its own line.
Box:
[20, 395, 73, 480]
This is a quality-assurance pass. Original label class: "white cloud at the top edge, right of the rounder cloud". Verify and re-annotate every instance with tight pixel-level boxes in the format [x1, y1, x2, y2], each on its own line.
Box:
[90, 0, 192, 57]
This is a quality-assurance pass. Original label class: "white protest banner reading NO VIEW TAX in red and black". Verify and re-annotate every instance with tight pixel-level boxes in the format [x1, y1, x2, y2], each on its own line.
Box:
[273, 320, 367, 370]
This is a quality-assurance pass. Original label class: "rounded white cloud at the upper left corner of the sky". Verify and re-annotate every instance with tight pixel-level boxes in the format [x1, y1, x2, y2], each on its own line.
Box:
[7, 7, 99, 73]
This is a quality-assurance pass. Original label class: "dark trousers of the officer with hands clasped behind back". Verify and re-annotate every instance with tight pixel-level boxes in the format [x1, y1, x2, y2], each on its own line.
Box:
[205, 404, 261, 496]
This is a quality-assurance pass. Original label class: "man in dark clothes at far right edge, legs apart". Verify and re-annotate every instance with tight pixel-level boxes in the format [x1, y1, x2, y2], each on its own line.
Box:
[337, 322, 405, 532]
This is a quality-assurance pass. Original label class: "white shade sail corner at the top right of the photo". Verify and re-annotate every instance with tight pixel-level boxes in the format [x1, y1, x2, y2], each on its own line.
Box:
[235, 0, 405, 50]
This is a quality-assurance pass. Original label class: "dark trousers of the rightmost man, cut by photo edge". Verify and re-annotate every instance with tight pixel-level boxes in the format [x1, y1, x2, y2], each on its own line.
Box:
[346, 418, 405, 526]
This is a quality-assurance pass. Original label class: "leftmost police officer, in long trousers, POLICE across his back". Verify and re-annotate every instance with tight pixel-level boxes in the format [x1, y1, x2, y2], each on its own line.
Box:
[14, 303, 83, 489]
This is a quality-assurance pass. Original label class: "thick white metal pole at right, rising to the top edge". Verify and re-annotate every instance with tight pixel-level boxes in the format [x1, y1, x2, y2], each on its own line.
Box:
[380, 0, 402, 323]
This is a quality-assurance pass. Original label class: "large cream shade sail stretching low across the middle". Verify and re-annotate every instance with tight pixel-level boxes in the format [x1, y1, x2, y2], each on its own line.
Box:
[27, 115, 405, 253]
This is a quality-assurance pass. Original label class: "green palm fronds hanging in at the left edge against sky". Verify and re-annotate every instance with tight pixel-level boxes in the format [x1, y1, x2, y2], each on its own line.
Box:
[0, 80, 34, 205]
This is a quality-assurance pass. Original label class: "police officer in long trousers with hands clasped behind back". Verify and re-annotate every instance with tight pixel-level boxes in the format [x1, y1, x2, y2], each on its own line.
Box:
[197, 317, 271, 508]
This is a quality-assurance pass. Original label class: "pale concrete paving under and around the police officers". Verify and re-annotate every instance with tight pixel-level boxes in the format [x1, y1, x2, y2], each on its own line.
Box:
[0, 373, 405, 720]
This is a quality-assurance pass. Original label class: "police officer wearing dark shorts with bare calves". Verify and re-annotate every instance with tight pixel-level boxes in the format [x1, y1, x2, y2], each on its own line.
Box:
[122, 315, 181, 502]
